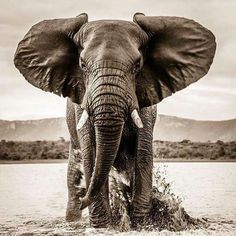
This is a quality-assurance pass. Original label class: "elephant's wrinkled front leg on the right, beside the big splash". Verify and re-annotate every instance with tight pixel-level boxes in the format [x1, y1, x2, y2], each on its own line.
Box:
[132, 107, 156, 226]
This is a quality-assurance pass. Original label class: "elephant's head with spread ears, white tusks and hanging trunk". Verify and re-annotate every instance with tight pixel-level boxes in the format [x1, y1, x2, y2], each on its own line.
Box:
[15, 13, 216, 209]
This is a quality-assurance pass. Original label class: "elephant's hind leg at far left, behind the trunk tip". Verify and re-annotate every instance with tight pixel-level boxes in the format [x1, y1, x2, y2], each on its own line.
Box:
[66, 142, 85, 221]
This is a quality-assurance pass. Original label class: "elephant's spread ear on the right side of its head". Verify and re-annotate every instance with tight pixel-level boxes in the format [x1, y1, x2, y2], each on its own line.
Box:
[134, 13, 216, 107]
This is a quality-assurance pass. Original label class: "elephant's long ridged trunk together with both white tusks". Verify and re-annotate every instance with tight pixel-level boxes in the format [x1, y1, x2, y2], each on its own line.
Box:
[77, 61, 143, 209]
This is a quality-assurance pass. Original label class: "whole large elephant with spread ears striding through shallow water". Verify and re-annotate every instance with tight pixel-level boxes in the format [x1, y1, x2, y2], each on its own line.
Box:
[14, 13, 216, 227]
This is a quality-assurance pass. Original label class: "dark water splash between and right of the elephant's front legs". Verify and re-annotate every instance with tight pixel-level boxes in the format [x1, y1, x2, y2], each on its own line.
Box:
[110, 168, 207, 231]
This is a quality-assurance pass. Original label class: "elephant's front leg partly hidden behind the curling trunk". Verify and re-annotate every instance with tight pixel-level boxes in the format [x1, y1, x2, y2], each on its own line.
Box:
[79, 122, 111, 228]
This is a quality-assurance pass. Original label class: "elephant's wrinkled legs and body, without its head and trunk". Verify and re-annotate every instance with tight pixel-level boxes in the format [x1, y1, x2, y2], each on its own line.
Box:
[67, 97, 156, 227]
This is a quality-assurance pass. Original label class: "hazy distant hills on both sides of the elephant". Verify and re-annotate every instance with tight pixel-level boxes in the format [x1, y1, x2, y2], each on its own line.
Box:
[0, 115, 236, 142]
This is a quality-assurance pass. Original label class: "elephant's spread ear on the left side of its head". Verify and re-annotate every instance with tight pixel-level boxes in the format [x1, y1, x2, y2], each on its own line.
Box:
[14, 14, 88, 103]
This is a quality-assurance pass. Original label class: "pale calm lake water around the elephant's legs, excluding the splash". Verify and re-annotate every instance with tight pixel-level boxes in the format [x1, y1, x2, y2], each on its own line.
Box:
[0, 162, 236, 235]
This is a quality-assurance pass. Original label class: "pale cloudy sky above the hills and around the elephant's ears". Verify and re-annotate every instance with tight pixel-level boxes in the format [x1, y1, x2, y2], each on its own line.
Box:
[0, 0, 236, 120]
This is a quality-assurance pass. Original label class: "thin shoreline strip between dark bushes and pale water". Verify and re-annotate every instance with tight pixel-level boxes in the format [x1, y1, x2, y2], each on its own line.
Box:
[0, 158, 236, 165]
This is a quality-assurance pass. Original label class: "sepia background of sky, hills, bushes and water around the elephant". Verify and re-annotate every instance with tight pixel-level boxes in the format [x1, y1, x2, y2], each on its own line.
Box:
[0, 0, 236, 236]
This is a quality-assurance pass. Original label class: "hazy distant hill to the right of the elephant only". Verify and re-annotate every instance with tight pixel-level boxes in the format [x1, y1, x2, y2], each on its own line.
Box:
[154, 115, 236, 142]
